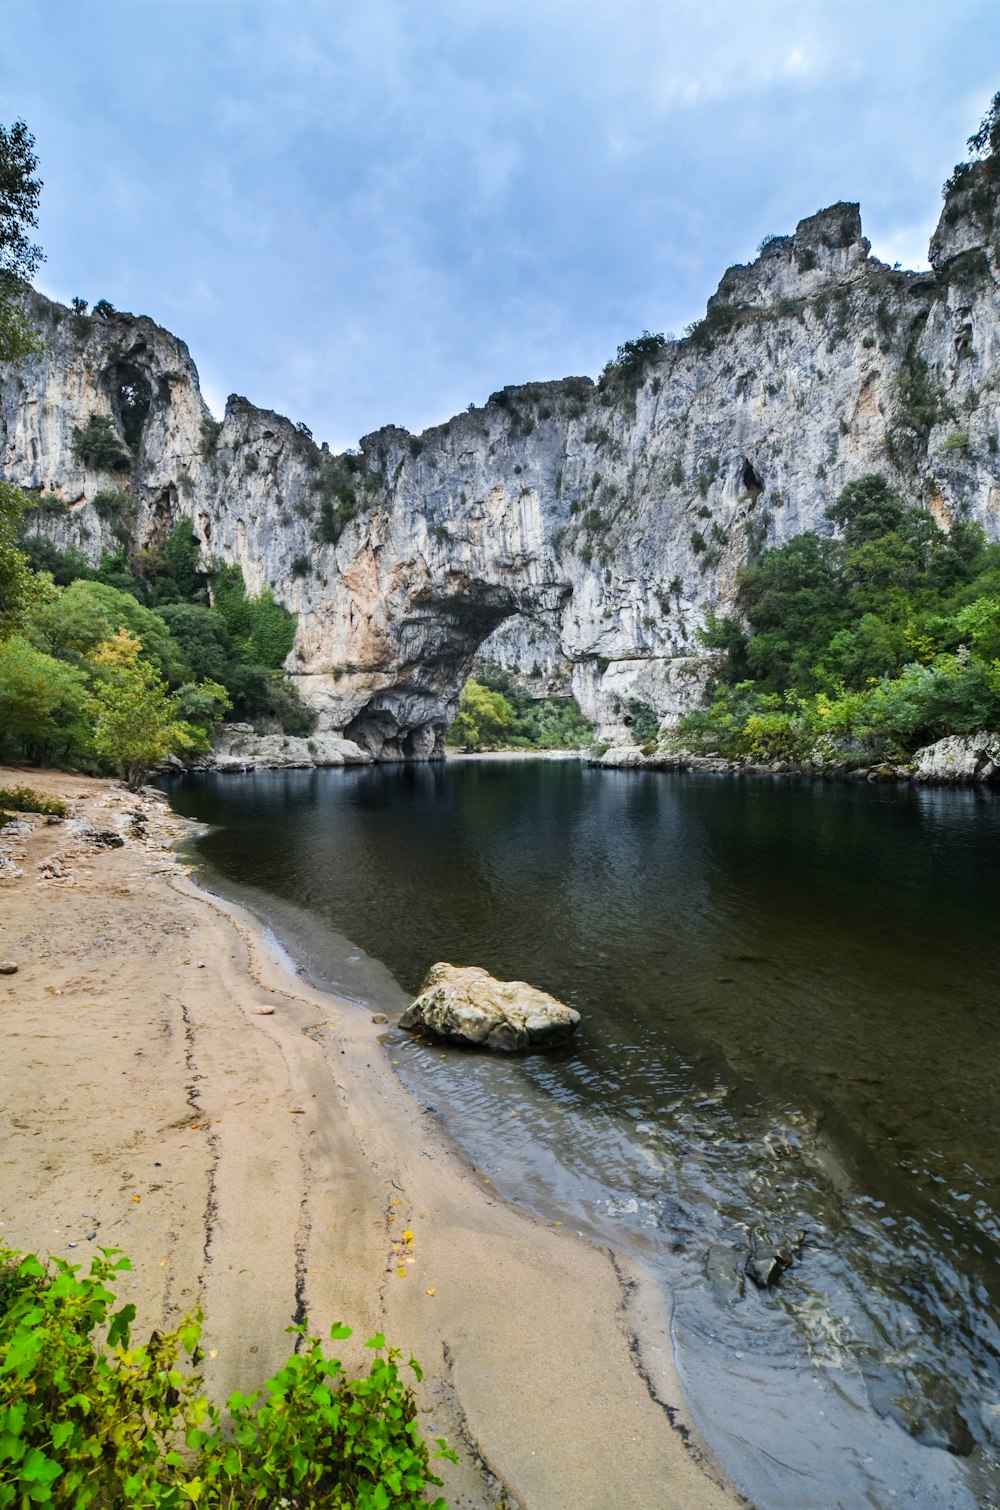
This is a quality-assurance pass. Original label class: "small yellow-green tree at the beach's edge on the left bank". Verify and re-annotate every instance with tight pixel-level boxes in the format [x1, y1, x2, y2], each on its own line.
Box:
[89, 630, 199, 791]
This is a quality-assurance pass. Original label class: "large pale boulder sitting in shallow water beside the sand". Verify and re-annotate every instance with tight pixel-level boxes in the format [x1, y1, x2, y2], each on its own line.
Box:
[399, 963, 580, 1054]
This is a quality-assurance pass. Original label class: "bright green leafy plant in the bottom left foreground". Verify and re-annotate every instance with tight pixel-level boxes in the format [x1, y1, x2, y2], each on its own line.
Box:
[0, 1249, 455, 1510]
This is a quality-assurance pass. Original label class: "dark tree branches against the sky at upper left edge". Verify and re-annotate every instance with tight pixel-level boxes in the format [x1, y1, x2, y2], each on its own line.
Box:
[0, 121, 42, 362]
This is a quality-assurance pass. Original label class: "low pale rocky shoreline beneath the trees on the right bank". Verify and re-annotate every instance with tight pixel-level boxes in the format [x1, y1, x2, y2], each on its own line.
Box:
[589, 731, 1000, 787]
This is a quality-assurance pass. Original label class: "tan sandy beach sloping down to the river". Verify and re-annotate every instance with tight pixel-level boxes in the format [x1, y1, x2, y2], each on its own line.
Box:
[0, 769, 742, 1510]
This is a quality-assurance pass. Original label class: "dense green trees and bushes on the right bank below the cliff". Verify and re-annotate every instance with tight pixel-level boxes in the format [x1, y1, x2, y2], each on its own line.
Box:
[671, 474, 1000, 761]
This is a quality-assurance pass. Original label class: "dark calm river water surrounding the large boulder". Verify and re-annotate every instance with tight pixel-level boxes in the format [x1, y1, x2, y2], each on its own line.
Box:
[172, 761, 1000, 1510]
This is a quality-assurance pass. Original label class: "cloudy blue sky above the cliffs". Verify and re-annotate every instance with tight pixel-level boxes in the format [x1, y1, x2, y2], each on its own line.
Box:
[0, 0, 1000, 450]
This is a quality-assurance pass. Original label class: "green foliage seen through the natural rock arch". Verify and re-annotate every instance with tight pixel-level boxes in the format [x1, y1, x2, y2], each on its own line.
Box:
[447, 664, 594, 749]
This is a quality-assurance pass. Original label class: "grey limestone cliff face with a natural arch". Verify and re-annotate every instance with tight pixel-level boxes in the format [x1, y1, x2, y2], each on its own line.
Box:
[0, 175, 1000, 758]
